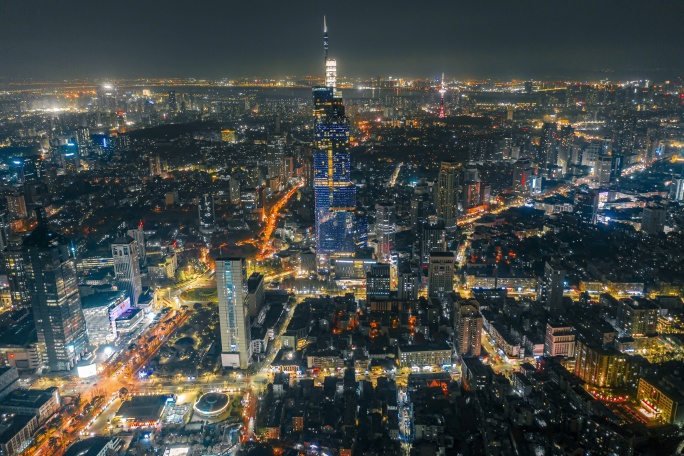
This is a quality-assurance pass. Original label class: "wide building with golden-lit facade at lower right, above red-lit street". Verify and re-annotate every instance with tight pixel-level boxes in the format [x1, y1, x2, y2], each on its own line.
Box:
[575, 341, 630, 388]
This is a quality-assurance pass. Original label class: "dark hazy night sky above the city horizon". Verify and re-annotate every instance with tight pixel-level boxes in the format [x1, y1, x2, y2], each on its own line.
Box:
[0, 0, 684, 80]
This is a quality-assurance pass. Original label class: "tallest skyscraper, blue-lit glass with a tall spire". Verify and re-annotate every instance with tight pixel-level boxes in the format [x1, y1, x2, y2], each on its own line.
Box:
[313, 20, 356, 255]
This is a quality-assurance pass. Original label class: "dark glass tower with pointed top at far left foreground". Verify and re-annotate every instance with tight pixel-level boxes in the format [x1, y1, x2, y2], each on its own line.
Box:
[22, 209, 87, 371]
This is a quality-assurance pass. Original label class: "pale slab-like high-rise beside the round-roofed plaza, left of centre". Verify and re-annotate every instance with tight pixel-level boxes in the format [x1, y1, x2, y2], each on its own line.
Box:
[216, 258, 252, 369]
